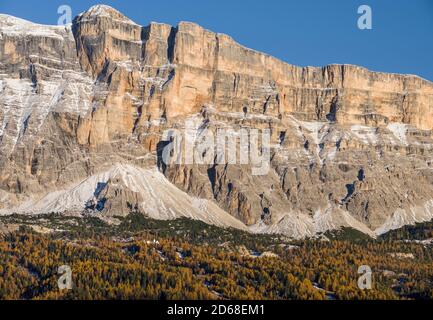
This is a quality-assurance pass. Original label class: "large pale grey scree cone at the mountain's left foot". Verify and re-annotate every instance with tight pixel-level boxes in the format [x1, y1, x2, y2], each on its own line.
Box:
[0, 164, 247, 230]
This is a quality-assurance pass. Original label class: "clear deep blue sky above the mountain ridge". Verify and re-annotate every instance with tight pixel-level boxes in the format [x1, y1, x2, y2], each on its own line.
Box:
[0, 0, 433, 81]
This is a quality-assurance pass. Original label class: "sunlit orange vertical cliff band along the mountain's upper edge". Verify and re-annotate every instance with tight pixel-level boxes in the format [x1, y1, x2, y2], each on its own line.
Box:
[68, 9, 433, 143]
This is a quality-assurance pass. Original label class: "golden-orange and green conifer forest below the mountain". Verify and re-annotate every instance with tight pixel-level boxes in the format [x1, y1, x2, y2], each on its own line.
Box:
[0, 214, 433, 300]
